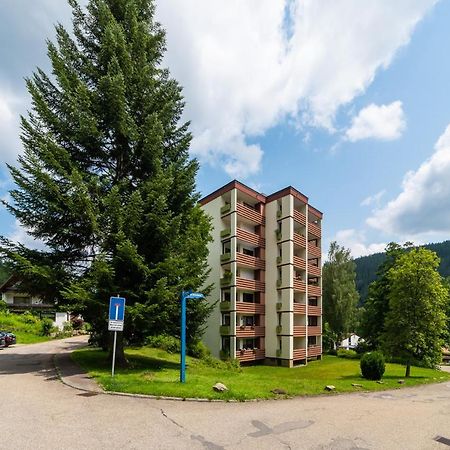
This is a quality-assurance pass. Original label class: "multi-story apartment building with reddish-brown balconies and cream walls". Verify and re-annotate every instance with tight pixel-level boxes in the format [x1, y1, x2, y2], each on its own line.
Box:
[200, 181, 322, 367]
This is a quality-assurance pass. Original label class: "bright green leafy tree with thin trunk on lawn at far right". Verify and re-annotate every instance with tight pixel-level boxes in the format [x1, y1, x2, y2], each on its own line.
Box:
[382, 248, 449, 376]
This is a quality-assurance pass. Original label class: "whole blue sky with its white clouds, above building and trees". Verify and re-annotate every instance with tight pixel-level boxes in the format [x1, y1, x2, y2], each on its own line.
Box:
[0, 0, 450, 256]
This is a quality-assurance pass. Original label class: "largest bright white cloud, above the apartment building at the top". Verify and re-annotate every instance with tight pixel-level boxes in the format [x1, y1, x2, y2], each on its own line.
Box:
[157, 0, 436, 177]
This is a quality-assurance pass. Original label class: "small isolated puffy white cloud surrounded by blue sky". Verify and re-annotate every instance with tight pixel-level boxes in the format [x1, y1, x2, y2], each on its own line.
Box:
[345, 100, 406, 142]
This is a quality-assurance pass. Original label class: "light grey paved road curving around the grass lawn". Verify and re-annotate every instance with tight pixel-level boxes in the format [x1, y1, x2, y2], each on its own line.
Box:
[0, 338, 450, 450]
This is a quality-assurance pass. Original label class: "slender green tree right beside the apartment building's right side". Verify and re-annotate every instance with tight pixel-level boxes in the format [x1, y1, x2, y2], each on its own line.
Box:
[322, 242, 358, 340]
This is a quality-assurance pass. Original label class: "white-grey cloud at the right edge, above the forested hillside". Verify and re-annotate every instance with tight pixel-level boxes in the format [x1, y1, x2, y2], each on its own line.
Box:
[367, 124, 450, 238]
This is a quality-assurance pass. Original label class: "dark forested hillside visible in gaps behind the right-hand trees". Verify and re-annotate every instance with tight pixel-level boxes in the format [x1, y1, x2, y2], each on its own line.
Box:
[355, 241, 450, 304]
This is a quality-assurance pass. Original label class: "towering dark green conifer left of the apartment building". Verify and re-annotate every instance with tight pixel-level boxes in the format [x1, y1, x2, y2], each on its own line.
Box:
[2, 0, 214, 360]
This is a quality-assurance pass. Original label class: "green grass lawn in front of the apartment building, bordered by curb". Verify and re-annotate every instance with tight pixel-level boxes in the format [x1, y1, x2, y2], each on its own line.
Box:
[72, 347, 450, 400]
